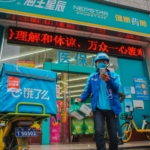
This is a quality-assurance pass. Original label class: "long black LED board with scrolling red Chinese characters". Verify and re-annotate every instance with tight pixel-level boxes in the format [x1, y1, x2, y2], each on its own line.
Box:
[7, 27, 143, 59]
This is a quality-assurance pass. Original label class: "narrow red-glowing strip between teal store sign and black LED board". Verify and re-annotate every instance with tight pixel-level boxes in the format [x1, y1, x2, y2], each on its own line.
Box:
[0, 14, 146, 41]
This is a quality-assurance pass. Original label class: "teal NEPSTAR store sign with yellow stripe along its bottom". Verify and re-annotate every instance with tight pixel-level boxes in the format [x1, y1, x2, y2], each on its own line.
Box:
[0, 0, 150, 37]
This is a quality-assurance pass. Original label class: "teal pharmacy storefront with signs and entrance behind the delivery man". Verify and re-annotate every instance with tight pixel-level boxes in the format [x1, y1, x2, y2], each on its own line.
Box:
[0, 0, 150, 144]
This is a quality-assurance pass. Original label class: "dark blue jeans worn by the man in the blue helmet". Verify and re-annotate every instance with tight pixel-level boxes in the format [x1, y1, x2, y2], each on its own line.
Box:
[93, 108, 118, 150]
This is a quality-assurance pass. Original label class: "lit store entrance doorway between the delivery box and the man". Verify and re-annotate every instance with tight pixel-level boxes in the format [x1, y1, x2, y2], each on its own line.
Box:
[55, 72, 94, 143]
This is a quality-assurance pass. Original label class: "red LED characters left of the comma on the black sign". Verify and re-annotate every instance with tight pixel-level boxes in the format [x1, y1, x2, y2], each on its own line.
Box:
[9, 29, 77, 47]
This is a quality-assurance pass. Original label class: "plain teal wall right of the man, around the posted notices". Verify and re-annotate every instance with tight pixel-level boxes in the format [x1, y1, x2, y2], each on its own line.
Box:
[118, 58, 150, 128]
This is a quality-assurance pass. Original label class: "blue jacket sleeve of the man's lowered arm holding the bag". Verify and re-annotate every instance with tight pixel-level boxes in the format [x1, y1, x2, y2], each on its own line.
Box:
[80, 76, 91, 102]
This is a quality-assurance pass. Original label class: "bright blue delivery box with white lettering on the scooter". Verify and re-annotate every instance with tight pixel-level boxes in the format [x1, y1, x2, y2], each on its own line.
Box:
[0, 64, 57, 115]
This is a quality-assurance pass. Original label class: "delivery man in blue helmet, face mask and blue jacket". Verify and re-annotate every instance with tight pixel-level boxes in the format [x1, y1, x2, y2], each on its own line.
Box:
[77, 53, 121, 150]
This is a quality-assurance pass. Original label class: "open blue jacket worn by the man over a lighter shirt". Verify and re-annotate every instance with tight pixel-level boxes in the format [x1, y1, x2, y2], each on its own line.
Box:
[80, 69, 122, 114]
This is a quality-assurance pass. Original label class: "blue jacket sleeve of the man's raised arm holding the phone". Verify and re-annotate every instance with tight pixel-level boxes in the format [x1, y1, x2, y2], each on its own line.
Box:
[106, 75, 121, 93]
